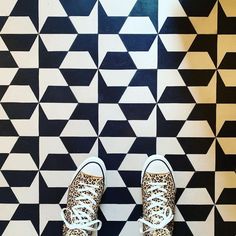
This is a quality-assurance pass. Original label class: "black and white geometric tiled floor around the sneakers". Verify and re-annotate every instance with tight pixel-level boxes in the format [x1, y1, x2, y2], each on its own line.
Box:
[0, 0, 236, 236]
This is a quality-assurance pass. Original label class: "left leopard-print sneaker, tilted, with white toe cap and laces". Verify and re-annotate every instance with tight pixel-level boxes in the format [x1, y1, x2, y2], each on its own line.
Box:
[61, 157, 106, 236]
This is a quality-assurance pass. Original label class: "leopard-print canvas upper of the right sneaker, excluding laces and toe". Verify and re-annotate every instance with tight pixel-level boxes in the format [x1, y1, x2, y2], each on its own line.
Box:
[142, 172, 175, 236]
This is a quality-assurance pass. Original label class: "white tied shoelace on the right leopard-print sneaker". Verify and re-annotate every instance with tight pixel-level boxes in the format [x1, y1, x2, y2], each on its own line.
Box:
[139, 183, 174, 234]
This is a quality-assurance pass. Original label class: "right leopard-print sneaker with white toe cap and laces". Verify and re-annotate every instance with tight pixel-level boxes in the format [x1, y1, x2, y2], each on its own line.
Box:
[139, 155, 175, 236]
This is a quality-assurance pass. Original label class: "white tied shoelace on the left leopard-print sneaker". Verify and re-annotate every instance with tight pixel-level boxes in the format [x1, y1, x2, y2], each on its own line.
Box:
[61, 183, 102, 236]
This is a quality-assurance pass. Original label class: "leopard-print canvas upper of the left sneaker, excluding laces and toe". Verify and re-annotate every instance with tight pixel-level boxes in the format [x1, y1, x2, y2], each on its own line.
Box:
[63, 172, 105, 236]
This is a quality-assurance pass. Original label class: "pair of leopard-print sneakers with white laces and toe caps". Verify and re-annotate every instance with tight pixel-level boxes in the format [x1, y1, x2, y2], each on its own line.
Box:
[61, 155, 175, 236]
